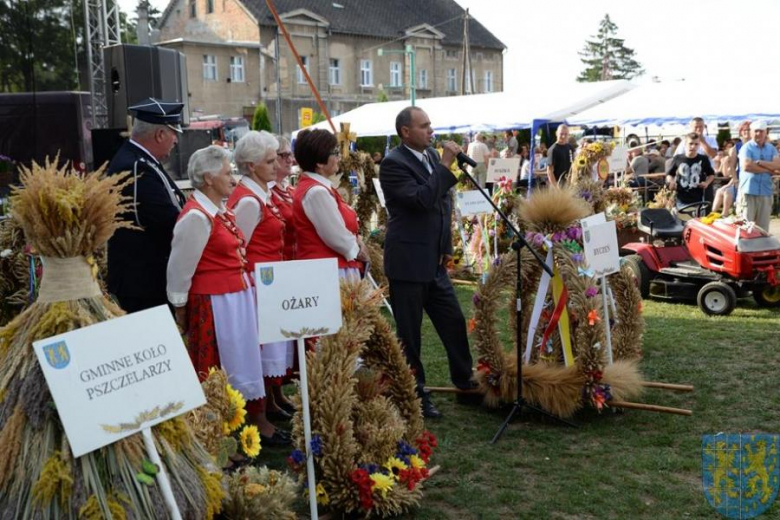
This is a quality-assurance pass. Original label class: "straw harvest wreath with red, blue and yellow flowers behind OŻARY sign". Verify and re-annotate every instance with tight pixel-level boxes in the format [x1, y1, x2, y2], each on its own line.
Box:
[288, 281, 436, 518]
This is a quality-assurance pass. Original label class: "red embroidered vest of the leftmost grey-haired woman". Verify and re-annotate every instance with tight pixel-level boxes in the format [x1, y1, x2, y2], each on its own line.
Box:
[179, 197, 248, 294]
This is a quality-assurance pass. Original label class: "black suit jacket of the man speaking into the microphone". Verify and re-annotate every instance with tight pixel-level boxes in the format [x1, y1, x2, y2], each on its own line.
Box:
[379, 145, 458, 282]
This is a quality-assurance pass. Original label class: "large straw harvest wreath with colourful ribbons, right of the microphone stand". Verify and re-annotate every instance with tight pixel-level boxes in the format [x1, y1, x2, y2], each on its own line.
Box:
[470, 189, 644, 417]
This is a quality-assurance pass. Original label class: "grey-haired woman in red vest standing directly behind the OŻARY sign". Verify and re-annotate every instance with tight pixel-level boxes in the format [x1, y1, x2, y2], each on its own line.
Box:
[228, 131, 294, 444]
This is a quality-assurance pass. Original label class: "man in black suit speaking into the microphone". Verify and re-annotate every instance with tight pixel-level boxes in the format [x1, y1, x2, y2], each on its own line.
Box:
[379, 107, 475, 418]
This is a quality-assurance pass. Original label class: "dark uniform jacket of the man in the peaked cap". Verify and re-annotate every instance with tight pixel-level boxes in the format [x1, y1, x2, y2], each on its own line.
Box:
[108, 141, 185, 302]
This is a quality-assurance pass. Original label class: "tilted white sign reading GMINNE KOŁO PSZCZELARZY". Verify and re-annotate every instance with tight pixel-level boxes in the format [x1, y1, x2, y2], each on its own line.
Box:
[33, 306, 206, 457]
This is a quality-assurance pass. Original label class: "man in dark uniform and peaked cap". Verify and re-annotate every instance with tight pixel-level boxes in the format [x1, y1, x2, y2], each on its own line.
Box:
[108, 98, 185, 312]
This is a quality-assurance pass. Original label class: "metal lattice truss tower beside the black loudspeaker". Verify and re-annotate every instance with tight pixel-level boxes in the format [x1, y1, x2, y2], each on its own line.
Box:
[84, 0, 122, 128]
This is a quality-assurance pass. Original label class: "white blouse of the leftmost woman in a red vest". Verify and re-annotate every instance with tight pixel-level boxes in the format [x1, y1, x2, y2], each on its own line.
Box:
[167, 190, 225, 307]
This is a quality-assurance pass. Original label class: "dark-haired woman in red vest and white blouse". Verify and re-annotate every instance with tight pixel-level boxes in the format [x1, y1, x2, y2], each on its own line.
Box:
[293, 130, 369, 280]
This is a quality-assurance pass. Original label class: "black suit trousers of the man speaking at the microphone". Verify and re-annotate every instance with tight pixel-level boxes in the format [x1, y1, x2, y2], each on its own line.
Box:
[389, 266, 473, 395]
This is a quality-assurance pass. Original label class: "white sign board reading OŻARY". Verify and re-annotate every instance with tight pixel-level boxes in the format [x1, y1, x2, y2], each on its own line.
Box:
[255, 258, 341, 343]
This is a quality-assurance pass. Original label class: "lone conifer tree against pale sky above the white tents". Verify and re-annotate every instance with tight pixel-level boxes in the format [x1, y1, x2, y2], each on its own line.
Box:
[577, 14, 644, 82]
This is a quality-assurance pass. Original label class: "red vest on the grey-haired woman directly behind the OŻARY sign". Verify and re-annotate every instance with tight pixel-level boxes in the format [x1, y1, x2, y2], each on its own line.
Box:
[228, 183, 286, 272]
